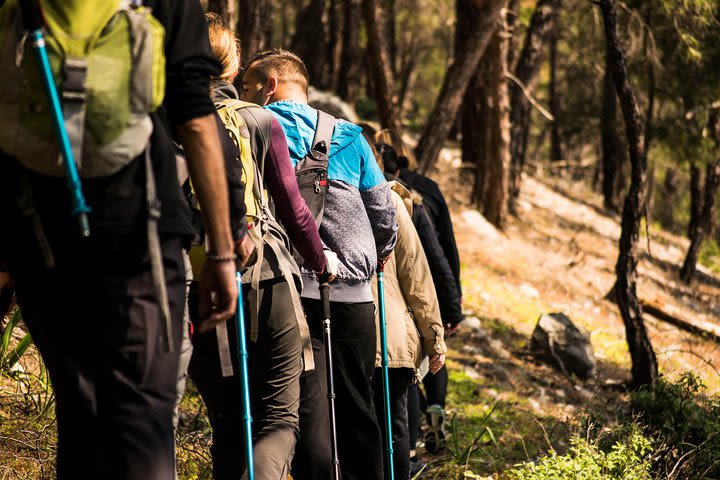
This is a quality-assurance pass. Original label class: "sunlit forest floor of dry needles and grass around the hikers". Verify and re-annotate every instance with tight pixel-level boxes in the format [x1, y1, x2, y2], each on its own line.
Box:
[0, 150, 720, 480]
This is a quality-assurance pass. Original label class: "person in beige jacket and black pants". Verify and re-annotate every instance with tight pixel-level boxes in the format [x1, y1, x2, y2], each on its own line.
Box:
[372, 182, 447, 479]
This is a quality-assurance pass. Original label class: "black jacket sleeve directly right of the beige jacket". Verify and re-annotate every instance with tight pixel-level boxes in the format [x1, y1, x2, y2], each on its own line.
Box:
[412, 204, 463, 325]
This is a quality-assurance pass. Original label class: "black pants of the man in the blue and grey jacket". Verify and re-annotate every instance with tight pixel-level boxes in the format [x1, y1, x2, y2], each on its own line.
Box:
[291, 298, 383, 480]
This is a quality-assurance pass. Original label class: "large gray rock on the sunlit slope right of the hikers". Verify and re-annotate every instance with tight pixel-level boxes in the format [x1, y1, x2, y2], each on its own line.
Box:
[530, 313, 597, 379]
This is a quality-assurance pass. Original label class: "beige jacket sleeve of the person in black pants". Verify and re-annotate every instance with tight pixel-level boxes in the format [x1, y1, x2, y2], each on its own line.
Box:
[393, 193, 447, 356]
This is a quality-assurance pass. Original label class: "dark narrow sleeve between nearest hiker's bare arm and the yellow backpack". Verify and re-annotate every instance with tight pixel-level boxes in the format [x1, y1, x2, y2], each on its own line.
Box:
[213, 110, 247, 241]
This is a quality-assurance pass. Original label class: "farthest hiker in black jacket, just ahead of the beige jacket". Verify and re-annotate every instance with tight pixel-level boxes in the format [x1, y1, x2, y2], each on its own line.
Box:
[375, 129, 462, 453]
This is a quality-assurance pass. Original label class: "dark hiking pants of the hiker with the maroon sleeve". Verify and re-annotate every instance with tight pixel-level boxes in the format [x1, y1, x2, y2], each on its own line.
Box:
[189, 278, 302, 480]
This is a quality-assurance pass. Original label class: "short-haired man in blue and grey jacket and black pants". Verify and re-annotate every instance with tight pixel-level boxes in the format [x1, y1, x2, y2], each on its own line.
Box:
[243, 49, 397, 480]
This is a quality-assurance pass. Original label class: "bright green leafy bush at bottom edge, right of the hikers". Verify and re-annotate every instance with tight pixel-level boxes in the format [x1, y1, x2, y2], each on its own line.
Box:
[507, 427, 652, 480]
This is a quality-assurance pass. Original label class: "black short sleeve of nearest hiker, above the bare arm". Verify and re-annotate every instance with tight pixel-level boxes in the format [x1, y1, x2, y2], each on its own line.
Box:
[146, 0, 221, 128]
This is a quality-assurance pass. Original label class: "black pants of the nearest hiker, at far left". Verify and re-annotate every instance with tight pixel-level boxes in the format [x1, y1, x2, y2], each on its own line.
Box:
[0, 222, 185, 480]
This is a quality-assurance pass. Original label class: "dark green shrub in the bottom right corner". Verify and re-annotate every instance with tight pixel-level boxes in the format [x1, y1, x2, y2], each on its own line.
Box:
[630, 373, 720, 479]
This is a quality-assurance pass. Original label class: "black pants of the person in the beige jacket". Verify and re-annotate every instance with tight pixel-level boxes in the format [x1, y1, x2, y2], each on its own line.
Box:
[373, 368, 415, 480]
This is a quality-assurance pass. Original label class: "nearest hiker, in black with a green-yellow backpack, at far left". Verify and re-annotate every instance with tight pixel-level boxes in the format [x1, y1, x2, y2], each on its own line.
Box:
[0, 0, 237, 480]
